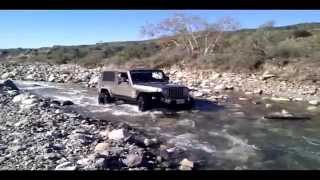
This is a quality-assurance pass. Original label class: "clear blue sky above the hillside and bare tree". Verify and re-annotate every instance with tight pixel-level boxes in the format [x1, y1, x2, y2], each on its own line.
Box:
[0, 10, 320, 49]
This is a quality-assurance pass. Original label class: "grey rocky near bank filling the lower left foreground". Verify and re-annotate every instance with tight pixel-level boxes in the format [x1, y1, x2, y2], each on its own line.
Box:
[0, 80, 195, 170]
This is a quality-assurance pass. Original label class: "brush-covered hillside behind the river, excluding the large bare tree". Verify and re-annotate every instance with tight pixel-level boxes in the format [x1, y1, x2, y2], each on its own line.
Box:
[0, 23, 320, 82]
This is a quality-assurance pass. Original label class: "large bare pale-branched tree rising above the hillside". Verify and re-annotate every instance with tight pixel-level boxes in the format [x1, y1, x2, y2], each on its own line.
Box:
[141, 13, 239, 55]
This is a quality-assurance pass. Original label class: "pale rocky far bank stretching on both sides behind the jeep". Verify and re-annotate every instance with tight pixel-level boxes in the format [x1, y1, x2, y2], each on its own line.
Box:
[0, 63, 320, 105]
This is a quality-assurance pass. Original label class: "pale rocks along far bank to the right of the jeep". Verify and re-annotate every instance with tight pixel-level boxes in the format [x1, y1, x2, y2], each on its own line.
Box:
[164, 66, 320, 101]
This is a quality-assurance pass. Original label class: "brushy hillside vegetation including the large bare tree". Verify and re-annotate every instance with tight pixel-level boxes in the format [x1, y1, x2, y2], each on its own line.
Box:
[0, 14, 320, 82]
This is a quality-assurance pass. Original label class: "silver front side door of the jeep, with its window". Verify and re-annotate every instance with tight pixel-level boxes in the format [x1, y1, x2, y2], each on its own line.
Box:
[114, 72, 134, 99]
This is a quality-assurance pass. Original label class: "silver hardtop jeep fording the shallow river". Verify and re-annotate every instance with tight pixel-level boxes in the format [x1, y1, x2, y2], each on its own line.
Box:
[98, 69, 194, 111]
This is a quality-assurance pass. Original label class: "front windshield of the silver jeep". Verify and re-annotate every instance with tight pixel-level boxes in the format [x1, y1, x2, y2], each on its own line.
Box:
[130, 70, 167, 83]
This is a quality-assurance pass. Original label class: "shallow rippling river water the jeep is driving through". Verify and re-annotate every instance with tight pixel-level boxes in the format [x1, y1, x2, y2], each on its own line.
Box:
[12, 81, 320, 170]
